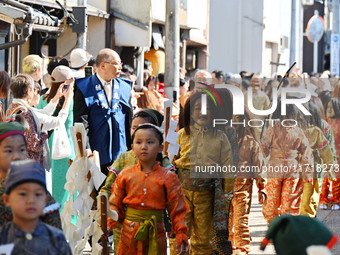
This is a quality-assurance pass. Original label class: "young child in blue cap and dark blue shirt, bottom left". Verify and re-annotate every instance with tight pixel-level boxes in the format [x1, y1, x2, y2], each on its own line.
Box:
[0, 160, 72, 255]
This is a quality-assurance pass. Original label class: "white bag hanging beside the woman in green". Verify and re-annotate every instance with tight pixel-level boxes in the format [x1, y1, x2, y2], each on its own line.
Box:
[52, 124, 72, 159]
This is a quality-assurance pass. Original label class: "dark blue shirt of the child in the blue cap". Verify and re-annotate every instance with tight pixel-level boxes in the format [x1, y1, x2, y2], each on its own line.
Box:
[0, 221, 72, 255]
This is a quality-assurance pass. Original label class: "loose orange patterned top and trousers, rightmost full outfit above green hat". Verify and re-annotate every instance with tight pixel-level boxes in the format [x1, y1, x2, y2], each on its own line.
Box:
[261, 123, 314, 223]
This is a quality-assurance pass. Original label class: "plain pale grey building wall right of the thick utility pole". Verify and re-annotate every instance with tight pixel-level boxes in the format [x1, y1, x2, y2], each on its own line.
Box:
[209, 0, 263, 73]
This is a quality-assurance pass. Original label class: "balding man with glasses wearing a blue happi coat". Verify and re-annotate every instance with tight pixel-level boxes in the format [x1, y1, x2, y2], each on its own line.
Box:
[74, 48, 131, 175]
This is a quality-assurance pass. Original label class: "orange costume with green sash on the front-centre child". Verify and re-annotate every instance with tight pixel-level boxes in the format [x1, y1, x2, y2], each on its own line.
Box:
[109, 162, 188, 254]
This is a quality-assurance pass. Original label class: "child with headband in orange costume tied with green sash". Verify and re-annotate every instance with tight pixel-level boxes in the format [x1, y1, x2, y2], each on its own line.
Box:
[109, 124, 188, 255]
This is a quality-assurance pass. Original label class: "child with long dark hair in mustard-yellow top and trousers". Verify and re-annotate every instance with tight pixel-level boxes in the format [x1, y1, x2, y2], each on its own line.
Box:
[174, 93, 236, 254]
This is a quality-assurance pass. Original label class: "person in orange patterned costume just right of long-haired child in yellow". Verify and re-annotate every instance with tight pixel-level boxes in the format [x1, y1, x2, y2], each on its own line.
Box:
[229, 107, 265, 254]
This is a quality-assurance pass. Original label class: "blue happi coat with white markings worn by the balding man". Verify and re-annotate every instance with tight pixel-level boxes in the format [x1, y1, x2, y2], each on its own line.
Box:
[75, 75, 131, 165]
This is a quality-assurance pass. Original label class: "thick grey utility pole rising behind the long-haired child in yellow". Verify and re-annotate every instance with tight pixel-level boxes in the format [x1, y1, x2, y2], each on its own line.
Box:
[164, 0, 180, 100]
